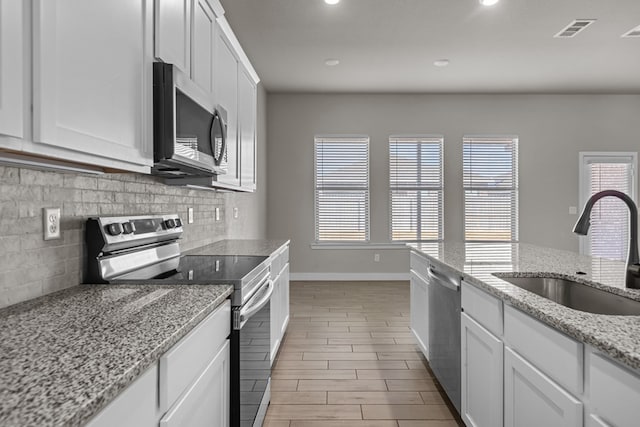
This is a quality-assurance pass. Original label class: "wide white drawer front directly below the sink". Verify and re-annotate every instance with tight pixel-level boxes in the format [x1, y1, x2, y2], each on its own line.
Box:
[504, 306, 584, 394]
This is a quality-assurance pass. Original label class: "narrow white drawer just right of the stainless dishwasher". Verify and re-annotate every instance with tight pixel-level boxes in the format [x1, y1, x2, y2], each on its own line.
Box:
[462, 281, 503, 337]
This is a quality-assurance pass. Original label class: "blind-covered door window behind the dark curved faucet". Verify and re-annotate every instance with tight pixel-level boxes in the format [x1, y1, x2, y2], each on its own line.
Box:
[580, 152, 637, 261]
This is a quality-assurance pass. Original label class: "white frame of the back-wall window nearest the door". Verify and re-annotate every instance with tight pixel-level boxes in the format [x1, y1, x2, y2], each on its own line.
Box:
[462, 134, 520, 243]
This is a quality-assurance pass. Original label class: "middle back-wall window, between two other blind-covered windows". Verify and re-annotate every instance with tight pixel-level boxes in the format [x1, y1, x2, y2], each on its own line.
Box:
[389, 136, 443, 242]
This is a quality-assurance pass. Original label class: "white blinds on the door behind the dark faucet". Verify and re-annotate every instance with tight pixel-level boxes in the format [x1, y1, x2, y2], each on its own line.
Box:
[586, 157, 633, 261]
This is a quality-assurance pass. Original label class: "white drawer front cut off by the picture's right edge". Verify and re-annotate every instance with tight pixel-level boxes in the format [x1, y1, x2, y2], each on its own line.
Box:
[589, 354, 640, 427]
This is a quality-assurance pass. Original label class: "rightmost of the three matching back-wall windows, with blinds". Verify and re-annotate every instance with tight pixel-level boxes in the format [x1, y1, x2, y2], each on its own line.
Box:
[463, 137, 518, 242]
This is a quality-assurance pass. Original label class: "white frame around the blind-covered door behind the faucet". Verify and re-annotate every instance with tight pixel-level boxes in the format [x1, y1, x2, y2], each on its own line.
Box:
[577, 151, 638, 256]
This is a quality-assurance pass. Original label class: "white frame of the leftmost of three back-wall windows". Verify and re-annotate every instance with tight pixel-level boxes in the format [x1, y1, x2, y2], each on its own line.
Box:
[312, 134, 371, 247]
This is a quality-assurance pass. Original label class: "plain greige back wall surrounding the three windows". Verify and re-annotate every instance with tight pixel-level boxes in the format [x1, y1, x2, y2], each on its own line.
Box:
[267, 93, 640, 278]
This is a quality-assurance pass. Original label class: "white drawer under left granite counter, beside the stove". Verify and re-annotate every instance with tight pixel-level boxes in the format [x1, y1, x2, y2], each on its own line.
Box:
[159, 300, 231, 413]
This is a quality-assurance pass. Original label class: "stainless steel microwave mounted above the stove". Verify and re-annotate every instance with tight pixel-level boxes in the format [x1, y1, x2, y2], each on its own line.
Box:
[152, 62, 227, 178]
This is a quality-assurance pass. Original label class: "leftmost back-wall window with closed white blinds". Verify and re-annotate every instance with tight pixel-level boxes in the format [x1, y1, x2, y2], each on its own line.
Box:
[315, 136, 369, 242]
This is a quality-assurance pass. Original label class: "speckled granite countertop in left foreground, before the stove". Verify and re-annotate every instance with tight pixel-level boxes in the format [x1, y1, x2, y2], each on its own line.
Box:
[0, 285, 233, 427]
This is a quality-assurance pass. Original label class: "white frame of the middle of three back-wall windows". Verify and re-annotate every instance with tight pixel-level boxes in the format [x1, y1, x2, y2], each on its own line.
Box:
[387, 134, 444, 244]
